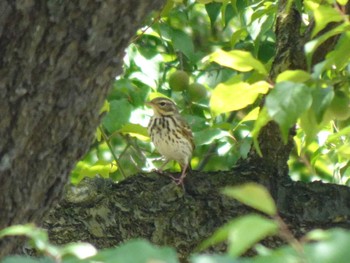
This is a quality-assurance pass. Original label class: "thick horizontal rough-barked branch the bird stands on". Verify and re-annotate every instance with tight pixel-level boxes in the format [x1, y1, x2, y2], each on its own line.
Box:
[44, 170, 350, 258]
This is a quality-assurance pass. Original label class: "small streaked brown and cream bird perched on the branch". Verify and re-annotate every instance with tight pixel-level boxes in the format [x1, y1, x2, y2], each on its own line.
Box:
[146, 97, 195, 186]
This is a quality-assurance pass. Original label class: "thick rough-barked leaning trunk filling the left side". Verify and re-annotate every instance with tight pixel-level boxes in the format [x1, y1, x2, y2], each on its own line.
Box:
[0, 0, 163, 258]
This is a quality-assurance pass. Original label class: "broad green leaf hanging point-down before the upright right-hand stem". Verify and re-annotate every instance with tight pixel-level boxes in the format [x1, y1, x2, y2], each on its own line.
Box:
[266, 82, 312, 143]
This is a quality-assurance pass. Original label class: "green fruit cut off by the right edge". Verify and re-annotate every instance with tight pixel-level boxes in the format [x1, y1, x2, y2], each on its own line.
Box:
[325, 91, 350, 120]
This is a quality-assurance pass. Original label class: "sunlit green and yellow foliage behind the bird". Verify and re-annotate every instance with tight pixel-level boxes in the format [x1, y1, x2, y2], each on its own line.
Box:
[72, 0, 350, 188]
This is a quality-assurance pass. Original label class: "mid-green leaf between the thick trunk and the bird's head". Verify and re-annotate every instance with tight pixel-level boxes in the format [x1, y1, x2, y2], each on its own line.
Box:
[102, 99, 133, 133]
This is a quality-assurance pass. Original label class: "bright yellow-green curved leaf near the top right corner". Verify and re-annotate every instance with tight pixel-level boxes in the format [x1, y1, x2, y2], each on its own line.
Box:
[312, 5, 343, 37]
